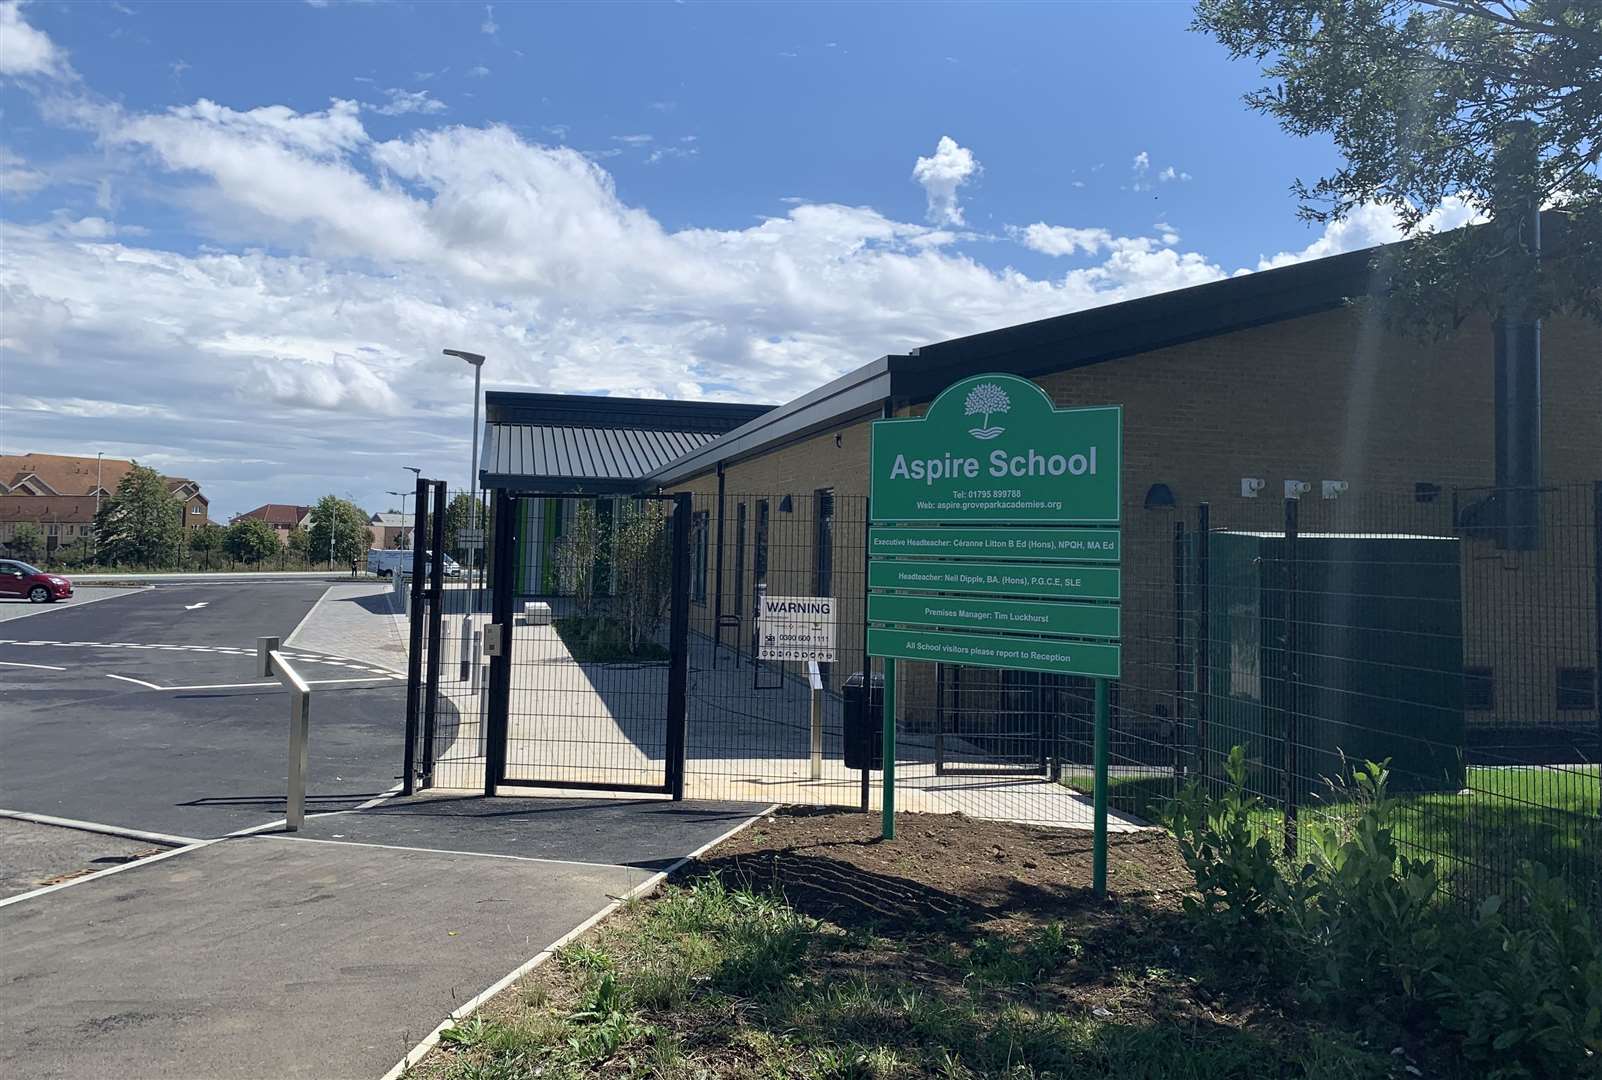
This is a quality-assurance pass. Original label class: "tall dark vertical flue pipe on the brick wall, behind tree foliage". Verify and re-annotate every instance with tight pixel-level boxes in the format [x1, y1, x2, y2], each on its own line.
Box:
[1490, 123, 1541, 551]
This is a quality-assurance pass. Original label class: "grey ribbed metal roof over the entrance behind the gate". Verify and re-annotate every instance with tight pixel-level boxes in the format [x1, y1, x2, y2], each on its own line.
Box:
[479, 391, 772, 494]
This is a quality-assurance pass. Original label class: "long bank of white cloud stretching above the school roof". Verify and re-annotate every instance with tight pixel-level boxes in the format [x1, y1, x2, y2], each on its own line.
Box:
[0, 62, 1384, 514]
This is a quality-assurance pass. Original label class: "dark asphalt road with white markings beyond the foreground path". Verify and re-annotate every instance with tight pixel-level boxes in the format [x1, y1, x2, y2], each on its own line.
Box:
[0, 582, 405, 838]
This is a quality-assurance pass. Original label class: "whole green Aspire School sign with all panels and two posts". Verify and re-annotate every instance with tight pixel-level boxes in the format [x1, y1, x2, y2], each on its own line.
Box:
[867, 375, 1123, 896]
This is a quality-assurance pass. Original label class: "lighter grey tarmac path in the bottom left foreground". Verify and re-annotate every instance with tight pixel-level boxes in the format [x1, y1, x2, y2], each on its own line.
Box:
[0, 838, 650, 1080]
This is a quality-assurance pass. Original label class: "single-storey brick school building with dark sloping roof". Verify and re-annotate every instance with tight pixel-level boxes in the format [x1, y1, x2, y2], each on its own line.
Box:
[481, 229, 1602, 775]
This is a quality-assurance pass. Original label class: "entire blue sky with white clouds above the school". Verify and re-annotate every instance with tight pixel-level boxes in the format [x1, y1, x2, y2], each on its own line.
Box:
[0, 0, 1454, 519]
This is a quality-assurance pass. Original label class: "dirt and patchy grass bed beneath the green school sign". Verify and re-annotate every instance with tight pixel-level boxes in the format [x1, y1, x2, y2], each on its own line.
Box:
[412, 811, 1435, 1080]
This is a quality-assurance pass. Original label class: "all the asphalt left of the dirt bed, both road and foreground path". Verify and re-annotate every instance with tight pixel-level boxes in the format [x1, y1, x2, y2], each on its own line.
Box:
[0, 582, 751, 1077]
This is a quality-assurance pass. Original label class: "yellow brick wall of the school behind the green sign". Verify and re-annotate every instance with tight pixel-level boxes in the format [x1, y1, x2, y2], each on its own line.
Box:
[666, 306, 1602, 737]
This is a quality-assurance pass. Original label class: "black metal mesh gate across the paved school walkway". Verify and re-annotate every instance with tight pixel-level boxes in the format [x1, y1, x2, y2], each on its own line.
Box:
[484, 492, 694, 798]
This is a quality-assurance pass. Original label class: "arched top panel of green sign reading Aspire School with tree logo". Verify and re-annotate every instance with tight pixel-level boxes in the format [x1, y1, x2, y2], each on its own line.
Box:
[868, 375, 1123, 524]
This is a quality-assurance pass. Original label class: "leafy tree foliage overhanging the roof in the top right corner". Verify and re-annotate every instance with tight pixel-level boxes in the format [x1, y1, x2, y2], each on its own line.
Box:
[1195, 0, 1602, 335]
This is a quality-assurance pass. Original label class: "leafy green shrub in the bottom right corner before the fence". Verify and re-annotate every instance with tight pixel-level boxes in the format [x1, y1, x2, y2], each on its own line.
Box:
[1168, 747, 1602, 1080]
